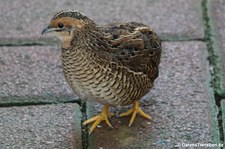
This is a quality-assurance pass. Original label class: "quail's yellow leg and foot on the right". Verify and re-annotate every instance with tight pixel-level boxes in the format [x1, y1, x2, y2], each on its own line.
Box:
[120, 101, 152, 127]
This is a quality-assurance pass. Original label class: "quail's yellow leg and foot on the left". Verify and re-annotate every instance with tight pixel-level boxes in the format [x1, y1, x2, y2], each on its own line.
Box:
[83, 105, 114, 134]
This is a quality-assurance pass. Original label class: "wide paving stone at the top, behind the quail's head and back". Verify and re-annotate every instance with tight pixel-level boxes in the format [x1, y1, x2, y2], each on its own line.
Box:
[0, 0, 203, 39]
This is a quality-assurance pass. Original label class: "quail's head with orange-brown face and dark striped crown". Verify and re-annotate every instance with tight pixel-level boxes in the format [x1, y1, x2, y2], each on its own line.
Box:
[42, 10, 94, 42]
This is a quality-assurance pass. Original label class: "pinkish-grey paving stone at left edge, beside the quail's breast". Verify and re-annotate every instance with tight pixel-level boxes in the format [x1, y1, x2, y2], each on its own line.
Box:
[0, 46, 77, 103]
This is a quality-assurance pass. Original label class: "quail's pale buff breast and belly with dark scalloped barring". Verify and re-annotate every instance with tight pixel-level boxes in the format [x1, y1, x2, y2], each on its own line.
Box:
[62, 51, 149, 106]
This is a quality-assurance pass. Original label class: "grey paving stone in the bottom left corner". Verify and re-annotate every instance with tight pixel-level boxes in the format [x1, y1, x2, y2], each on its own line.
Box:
[0, 104, 81, 149]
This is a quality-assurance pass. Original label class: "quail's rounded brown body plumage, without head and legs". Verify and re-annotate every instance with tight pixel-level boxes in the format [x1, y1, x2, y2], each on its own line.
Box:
[59, 19, 161, 105]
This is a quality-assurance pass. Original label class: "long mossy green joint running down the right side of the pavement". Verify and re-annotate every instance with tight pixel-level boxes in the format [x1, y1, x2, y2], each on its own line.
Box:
[202, 0, 224, 143]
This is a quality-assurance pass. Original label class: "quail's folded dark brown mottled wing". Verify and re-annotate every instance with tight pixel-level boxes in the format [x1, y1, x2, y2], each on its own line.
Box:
[101, 22, 161, 80]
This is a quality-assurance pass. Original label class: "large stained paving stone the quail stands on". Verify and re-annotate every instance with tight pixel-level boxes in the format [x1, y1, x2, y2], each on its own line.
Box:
[86, 41, 219, 149]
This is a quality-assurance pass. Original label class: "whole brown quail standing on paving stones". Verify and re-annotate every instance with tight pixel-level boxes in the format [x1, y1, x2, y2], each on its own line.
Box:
[42, 10, 162, 133]
